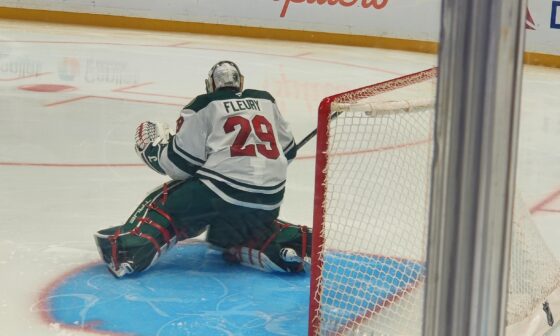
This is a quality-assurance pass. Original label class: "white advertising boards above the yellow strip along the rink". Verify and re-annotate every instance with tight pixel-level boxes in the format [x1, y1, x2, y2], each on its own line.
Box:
[0, 0, 560, 55]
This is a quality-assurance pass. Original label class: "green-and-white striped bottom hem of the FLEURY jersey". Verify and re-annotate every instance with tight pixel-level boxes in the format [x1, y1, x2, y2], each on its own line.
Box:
[200, 177, 284, 210]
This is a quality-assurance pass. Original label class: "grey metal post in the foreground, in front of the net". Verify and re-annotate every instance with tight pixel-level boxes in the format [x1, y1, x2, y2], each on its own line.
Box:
[423, 0, 526, 336]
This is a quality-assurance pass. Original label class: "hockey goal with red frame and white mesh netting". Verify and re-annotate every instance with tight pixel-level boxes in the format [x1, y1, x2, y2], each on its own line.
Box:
[309, 68, 560, 335]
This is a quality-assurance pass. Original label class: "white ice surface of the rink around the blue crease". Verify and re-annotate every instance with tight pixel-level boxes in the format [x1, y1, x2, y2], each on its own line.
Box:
[0, 21, 560, 336]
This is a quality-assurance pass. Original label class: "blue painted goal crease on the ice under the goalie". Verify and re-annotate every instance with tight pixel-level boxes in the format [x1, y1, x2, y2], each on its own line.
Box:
[47, 243, 423, 336]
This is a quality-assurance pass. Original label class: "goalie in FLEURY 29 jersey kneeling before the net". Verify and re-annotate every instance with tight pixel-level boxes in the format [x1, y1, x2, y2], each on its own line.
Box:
[95, 61, 311, 278]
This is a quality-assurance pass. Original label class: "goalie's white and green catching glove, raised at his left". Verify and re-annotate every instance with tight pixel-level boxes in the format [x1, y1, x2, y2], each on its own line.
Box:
[135, 121, 175, 175]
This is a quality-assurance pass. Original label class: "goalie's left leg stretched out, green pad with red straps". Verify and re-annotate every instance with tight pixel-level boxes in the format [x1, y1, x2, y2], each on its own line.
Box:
[94, 180, 218, 278]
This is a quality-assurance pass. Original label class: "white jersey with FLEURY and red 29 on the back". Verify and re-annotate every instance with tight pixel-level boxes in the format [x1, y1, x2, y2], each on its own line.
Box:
[159, 89, 296, 210]
